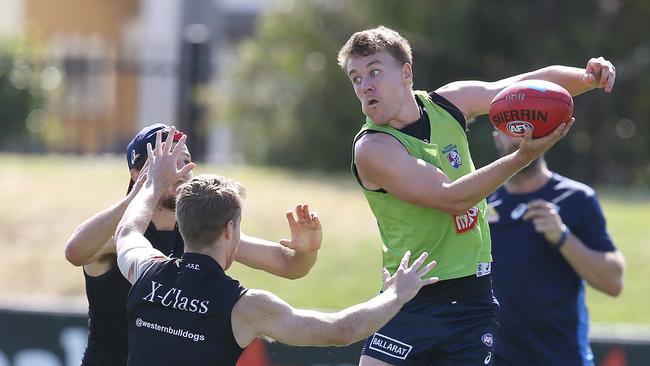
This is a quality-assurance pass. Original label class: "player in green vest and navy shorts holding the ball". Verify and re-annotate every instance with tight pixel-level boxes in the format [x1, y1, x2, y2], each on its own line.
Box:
[338, 27, 616, 366]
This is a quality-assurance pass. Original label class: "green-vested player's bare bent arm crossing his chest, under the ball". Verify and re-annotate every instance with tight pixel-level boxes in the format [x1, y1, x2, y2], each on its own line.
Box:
[354, 126, 573, 215]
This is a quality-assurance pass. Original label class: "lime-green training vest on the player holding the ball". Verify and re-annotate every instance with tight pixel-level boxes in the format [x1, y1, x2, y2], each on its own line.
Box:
[352, 91, 492, 280]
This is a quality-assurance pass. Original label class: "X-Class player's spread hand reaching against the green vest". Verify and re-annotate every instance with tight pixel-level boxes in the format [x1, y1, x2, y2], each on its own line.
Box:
[382, 250, 438, 302]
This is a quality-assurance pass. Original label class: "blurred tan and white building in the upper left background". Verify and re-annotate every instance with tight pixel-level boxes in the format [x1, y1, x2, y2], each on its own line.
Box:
[0, 0, 278, 163]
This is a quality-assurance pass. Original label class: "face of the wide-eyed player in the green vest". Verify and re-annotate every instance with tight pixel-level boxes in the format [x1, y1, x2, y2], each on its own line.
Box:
[347, 51, 412, 125]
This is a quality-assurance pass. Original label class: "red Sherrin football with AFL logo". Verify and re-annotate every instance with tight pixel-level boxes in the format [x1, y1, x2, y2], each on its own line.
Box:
[489, 80, 573, 138]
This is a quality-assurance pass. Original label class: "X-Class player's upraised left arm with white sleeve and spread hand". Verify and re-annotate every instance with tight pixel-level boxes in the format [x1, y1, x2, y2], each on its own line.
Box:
[115, 127, 194, 283]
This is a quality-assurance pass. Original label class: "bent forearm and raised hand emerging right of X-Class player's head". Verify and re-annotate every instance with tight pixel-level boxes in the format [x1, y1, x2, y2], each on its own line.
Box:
[235, 205, 323, 279]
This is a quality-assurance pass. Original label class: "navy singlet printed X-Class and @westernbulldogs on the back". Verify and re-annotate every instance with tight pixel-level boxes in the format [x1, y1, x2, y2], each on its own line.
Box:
[128, 253, 246, 366]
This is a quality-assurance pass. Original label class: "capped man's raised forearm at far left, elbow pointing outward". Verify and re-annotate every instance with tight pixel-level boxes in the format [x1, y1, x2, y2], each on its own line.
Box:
[65, 169, 144, 266]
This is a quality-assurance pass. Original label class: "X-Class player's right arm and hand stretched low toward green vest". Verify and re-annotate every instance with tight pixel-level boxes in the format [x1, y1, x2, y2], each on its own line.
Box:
[232, 252, 438, 347]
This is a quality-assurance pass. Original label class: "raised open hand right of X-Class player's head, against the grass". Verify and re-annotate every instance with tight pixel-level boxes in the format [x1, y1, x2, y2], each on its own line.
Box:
[280, 205, 323, 252]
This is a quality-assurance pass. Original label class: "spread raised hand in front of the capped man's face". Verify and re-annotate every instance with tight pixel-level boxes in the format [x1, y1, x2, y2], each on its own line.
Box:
[142, 126, 196, 190]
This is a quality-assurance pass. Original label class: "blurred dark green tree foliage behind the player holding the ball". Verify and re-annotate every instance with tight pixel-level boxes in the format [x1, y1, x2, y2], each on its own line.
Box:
[230, 0, 650, 185]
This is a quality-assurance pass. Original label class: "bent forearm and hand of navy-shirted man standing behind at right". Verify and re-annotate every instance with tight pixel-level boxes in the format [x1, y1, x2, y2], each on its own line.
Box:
[523, 200, 625, 296]
